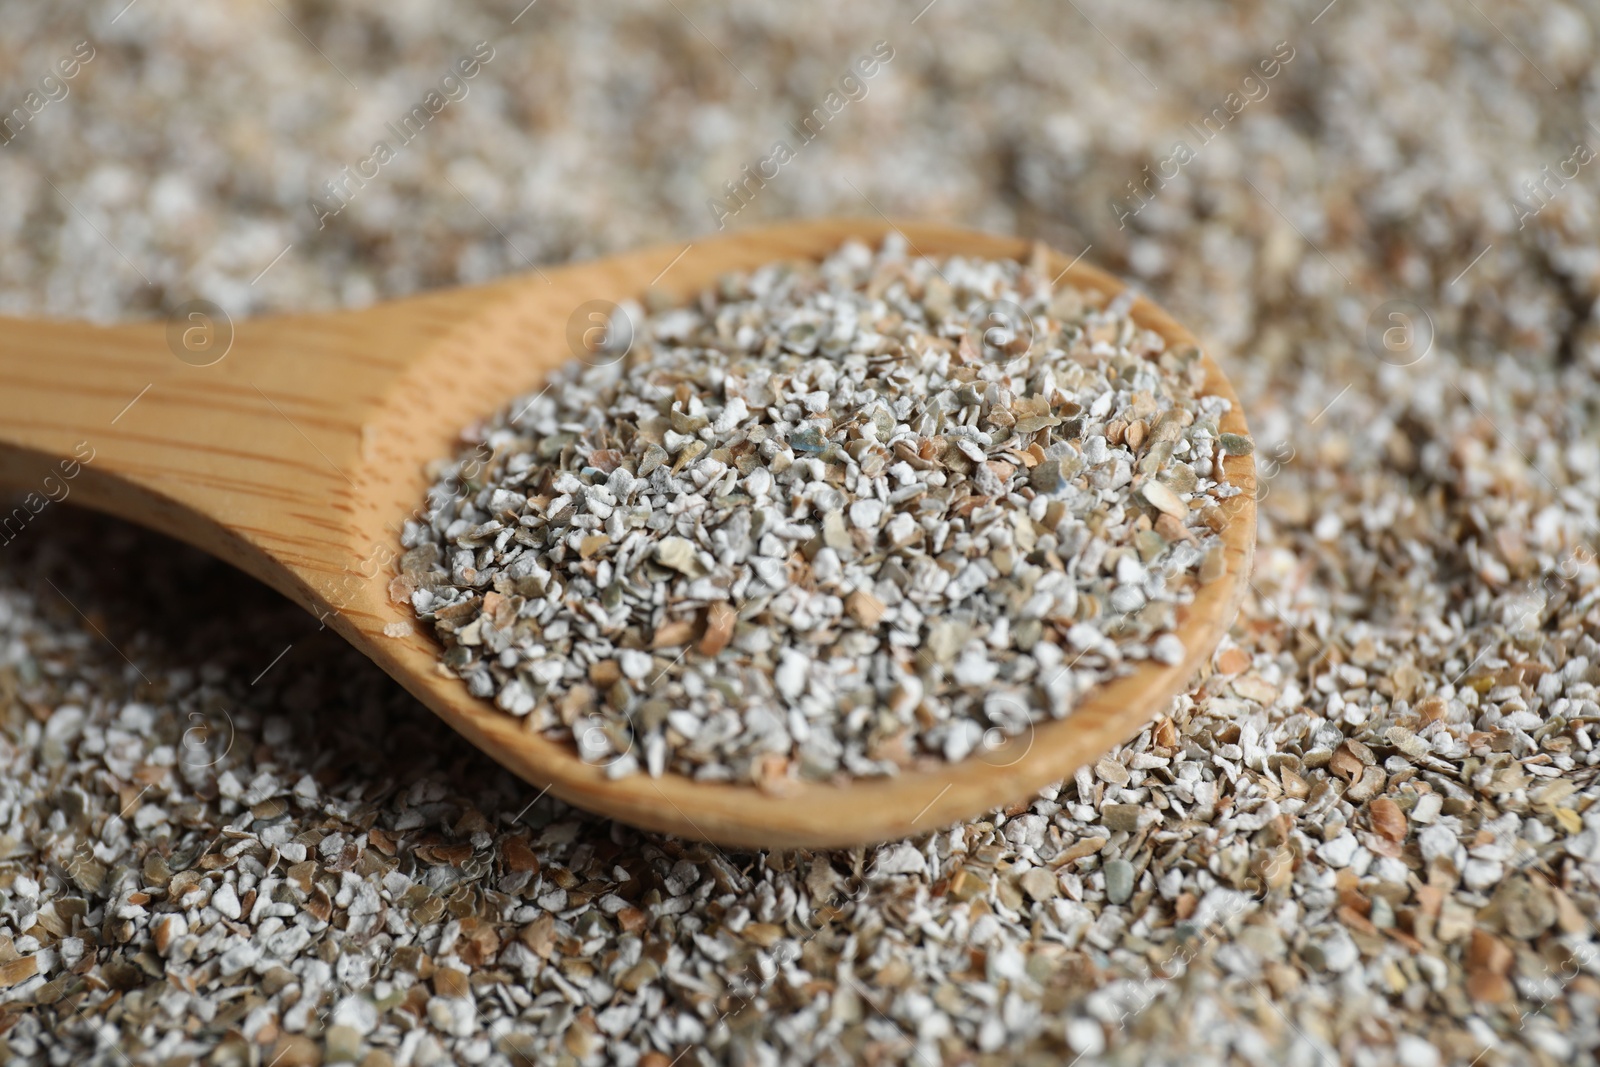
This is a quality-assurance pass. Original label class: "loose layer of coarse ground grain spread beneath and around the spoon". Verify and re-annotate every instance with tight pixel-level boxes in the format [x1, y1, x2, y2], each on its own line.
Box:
[0, 0, 1600, 1067]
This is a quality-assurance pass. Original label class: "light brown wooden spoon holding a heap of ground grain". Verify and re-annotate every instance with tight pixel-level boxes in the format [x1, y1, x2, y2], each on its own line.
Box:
[0, 219, 1256, 848]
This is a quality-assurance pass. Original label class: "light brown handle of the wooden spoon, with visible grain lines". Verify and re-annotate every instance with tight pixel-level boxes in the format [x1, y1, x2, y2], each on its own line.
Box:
[0, 300, 444, 603]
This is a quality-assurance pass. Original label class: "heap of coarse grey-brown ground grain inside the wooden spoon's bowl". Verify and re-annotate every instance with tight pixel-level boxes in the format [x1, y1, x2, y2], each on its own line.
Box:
[398, 239, 1248, 783]
